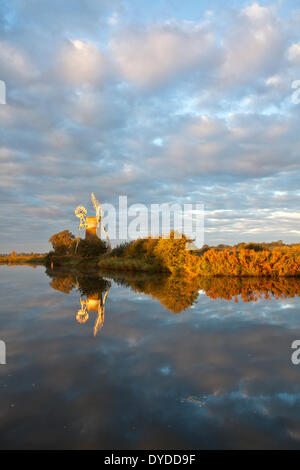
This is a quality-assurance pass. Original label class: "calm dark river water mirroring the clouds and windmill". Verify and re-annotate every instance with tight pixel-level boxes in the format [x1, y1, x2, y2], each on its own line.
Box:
[0, 266, 300, 449]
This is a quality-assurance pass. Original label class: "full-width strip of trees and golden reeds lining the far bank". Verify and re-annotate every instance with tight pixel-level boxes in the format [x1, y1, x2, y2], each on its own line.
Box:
[0, 230, 300, 282]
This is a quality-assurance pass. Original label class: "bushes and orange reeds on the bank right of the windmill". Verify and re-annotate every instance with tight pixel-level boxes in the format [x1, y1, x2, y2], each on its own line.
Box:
[99, 232, 300, 278]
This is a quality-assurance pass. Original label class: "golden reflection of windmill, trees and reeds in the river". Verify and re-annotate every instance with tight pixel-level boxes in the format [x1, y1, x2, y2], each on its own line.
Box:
[47, 270, 300, 320]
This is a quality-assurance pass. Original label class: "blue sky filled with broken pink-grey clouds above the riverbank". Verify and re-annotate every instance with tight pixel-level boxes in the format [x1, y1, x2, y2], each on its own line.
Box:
[0, 0, 300, 253]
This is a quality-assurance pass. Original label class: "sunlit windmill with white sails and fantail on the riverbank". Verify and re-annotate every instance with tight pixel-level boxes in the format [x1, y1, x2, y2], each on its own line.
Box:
[75, 193, 111, 253]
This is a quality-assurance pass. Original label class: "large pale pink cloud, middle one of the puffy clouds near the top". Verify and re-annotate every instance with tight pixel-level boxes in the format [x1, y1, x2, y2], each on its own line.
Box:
[110, 24, 218, 87]
